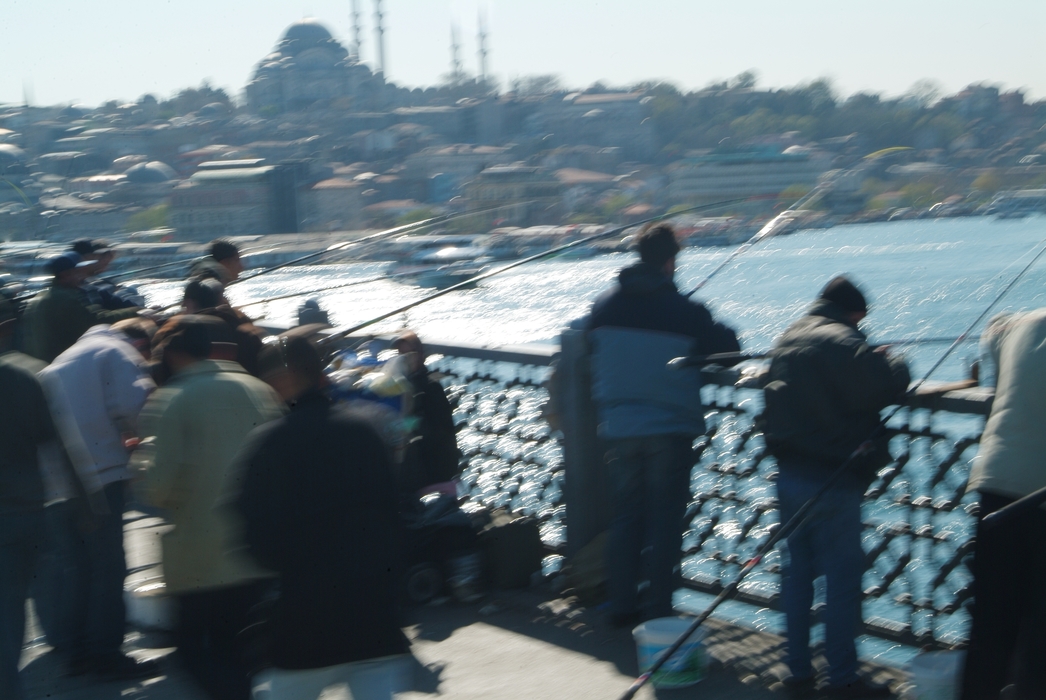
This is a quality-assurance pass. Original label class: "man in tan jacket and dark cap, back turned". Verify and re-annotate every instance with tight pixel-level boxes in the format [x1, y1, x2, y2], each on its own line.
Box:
[142, 315, 281, 700]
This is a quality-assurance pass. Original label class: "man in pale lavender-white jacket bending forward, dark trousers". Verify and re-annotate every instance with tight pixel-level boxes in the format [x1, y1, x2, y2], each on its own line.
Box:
[40, 320, 156, 679]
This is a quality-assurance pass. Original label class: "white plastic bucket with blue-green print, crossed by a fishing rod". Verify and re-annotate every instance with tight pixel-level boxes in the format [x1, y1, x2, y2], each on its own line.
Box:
[632, 617, 708, 688]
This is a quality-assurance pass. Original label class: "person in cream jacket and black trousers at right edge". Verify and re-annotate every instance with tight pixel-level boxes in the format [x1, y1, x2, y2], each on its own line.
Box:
[962, 309, 1046, 700]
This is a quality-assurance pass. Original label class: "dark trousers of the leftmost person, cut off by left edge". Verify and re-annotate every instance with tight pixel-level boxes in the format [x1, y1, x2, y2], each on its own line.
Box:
[0, 509, 45, 700]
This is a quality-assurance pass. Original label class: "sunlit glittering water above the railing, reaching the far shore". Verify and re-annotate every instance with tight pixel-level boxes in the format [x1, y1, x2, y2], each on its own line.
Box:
[134, 218, 1046, 380]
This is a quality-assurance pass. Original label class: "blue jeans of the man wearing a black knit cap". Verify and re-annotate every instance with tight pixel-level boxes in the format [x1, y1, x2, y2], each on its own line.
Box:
[777, 460, 865, 685]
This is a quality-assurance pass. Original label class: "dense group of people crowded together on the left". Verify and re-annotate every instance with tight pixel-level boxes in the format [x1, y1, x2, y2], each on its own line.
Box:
[0, 241, 458, 700]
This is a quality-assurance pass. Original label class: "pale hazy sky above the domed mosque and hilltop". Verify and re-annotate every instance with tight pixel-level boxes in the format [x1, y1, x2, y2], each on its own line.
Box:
[8, 0, 1046, 104]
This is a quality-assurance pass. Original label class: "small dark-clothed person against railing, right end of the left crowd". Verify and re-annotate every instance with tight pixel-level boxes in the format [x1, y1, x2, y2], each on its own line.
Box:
[392, 331, 461, 497]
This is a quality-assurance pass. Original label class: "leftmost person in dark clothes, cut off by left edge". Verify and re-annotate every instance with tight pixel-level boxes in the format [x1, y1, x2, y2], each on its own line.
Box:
[0, 297, 54, 700]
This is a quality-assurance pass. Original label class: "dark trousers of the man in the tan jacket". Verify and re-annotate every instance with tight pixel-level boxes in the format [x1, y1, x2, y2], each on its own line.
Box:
[175, 583, 264, 700]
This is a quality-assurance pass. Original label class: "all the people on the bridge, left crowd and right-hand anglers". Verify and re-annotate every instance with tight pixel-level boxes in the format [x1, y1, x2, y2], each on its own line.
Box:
[0, 224, 1046, 700]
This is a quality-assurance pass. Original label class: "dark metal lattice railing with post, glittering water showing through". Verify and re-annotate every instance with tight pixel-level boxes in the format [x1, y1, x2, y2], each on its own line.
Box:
[412, 336, 992, 648]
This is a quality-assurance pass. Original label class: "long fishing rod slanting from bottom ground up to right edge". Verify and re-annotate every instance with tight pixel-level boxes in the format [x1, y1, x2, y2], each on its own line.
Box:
[620, 236, 1046, 700]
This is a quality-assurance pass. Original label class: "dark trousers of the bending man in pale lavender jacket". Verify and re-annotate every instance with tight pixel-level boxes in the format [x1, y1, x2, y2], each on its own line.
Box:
[60, 481, 128, 662]
